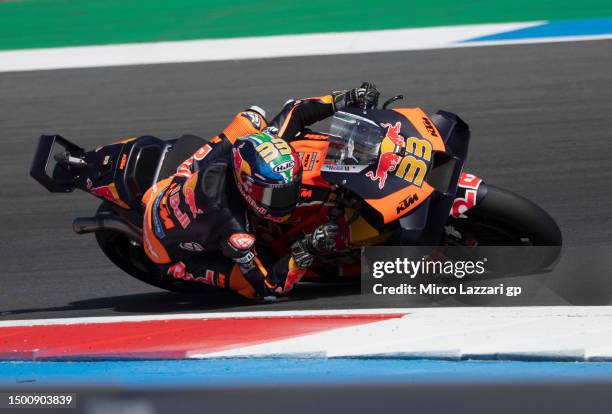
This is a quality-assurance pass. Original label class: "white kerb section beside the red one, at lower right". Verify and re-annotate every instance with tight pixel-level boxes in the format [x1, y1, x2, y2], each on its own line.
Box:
[188, 306, 612, 360]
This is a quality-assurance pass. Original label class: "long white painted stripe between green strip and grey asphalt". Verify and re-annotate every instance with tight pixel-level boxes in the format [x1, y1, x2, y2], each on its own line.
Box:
[0, 21, 546, 72]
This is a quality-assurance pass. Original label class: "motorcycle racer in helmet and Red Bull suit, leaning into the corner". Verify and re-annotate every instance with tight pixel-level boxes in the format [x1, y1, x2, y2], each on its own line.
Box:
[143, 83, 379, 299]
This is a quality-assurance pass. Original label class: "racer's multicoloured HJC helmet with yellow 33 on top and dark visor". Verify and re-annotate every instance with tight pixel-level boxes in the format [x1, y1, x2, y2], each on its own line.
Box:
[232, 132, 302, 222]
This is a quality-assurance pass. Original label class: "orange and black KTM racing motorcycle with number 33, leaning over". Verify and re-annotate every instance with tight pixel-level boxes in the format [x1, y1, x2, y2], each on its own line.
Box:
[31, 95, 561, 292]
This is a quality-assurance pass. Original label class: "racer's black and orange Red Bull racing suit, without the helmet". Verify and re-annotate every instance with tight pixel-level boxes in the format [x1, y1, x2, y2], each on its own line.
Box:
[143, 93, 342, 298]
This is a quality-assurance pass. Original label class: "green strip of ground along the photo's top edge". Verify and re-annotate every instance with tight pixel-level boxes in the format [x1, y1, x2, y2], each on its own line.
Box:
[0, 0, 612, 49]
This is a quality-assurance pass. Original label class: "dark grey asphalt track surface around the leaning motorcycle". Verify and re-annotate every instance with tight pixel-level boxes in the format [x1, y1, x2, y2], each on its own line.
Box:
[0, 40, 612, 319]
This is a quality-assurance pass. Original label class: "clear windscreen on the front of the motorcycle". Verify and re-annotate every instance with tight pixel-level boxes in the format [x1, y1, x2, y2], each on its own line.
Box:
[325, 112, 384, 165]
